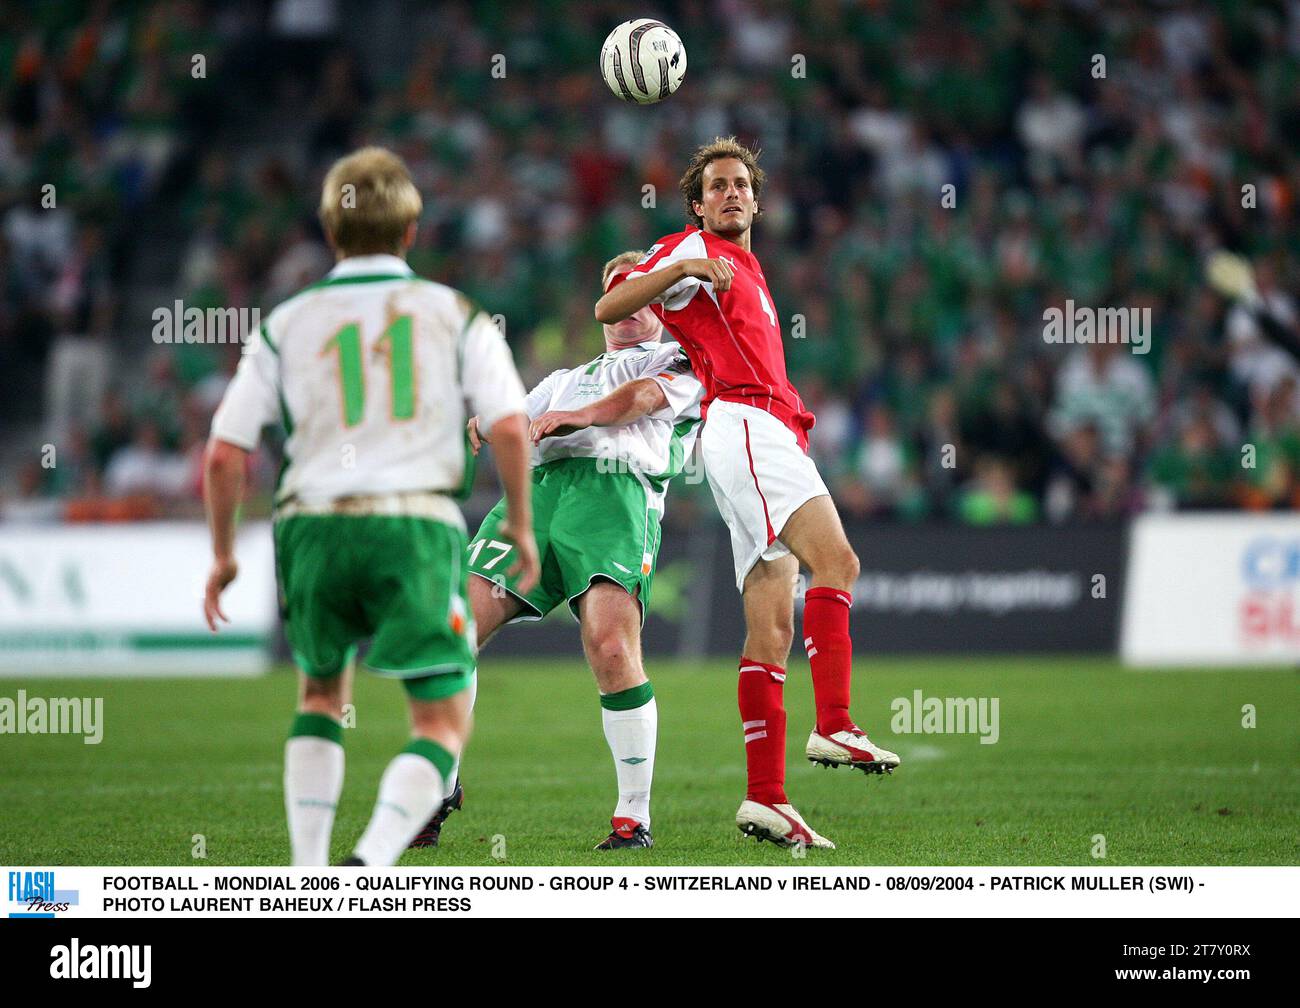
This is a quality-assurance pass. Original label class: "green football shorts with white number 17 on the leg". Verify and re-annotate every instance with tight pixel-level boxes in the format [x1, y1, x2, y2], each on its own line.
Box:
[469, 458, 660, 623]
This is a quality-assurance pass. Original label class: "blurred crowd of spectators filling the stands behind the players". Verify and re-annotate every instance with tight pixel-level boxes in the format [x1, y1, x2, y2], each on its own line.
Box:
[0, 0, 1300, 525]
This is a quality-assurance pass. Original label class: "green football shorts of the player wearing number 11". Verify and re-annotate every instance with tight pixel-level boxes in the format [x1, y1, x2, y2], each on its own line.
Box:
[274, 515, 475, 700]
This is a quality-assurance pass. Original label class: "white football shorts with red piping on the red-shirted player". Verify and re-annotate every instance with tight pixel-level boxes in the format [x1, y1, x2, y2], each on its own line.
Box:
[699, 399, 831, 590]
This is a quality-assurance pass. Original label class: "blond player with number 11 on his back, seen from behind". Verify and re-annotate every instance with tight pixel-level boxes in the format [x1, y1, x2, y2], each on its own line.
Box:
[204, 147, 538, 865]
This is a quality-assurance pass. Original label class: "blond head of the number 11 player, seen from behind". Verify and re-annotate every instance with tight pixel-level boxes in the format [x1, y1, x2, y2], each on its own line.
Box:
[320, 147, 424, 255]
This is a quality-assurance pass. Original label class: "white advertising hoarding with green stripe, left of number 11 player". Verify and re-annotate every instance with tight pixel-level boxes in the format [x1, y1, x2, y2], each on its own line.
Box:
[0, 522, 276, 676]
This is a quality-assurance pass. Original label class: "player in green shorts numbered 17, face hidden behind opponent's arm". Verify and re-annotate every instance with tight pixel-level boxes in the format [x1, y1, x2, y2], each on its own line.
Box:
[416, 252, 702, 851]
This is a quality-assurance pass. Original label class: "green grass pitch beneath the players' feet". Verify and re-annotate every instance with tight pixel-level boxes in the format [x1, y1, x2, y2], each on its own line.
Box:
[0, 654, 1300, 866]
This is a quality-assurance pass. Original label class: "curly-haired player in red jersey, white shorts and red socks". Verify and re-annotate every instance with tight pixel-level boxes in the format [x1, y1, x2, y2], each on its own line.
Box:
[595, 138, 898, 848]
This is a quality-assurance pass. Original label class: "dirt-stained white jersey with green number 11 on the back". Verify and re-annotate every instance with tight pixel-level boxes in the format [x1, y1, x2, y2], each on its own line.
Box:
[212, 255, 524, 505]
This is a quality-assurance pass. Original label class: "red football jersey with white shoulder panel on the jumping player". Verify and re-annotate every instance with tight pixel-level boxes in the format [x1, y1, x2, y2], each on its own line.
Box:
[610, 228, 815, 451]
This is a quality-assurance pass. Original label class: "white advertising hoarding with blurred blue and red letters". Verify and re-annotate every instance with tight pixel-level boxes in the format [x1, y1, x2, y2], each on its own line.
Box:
[1119, 512, 1300, 666]
